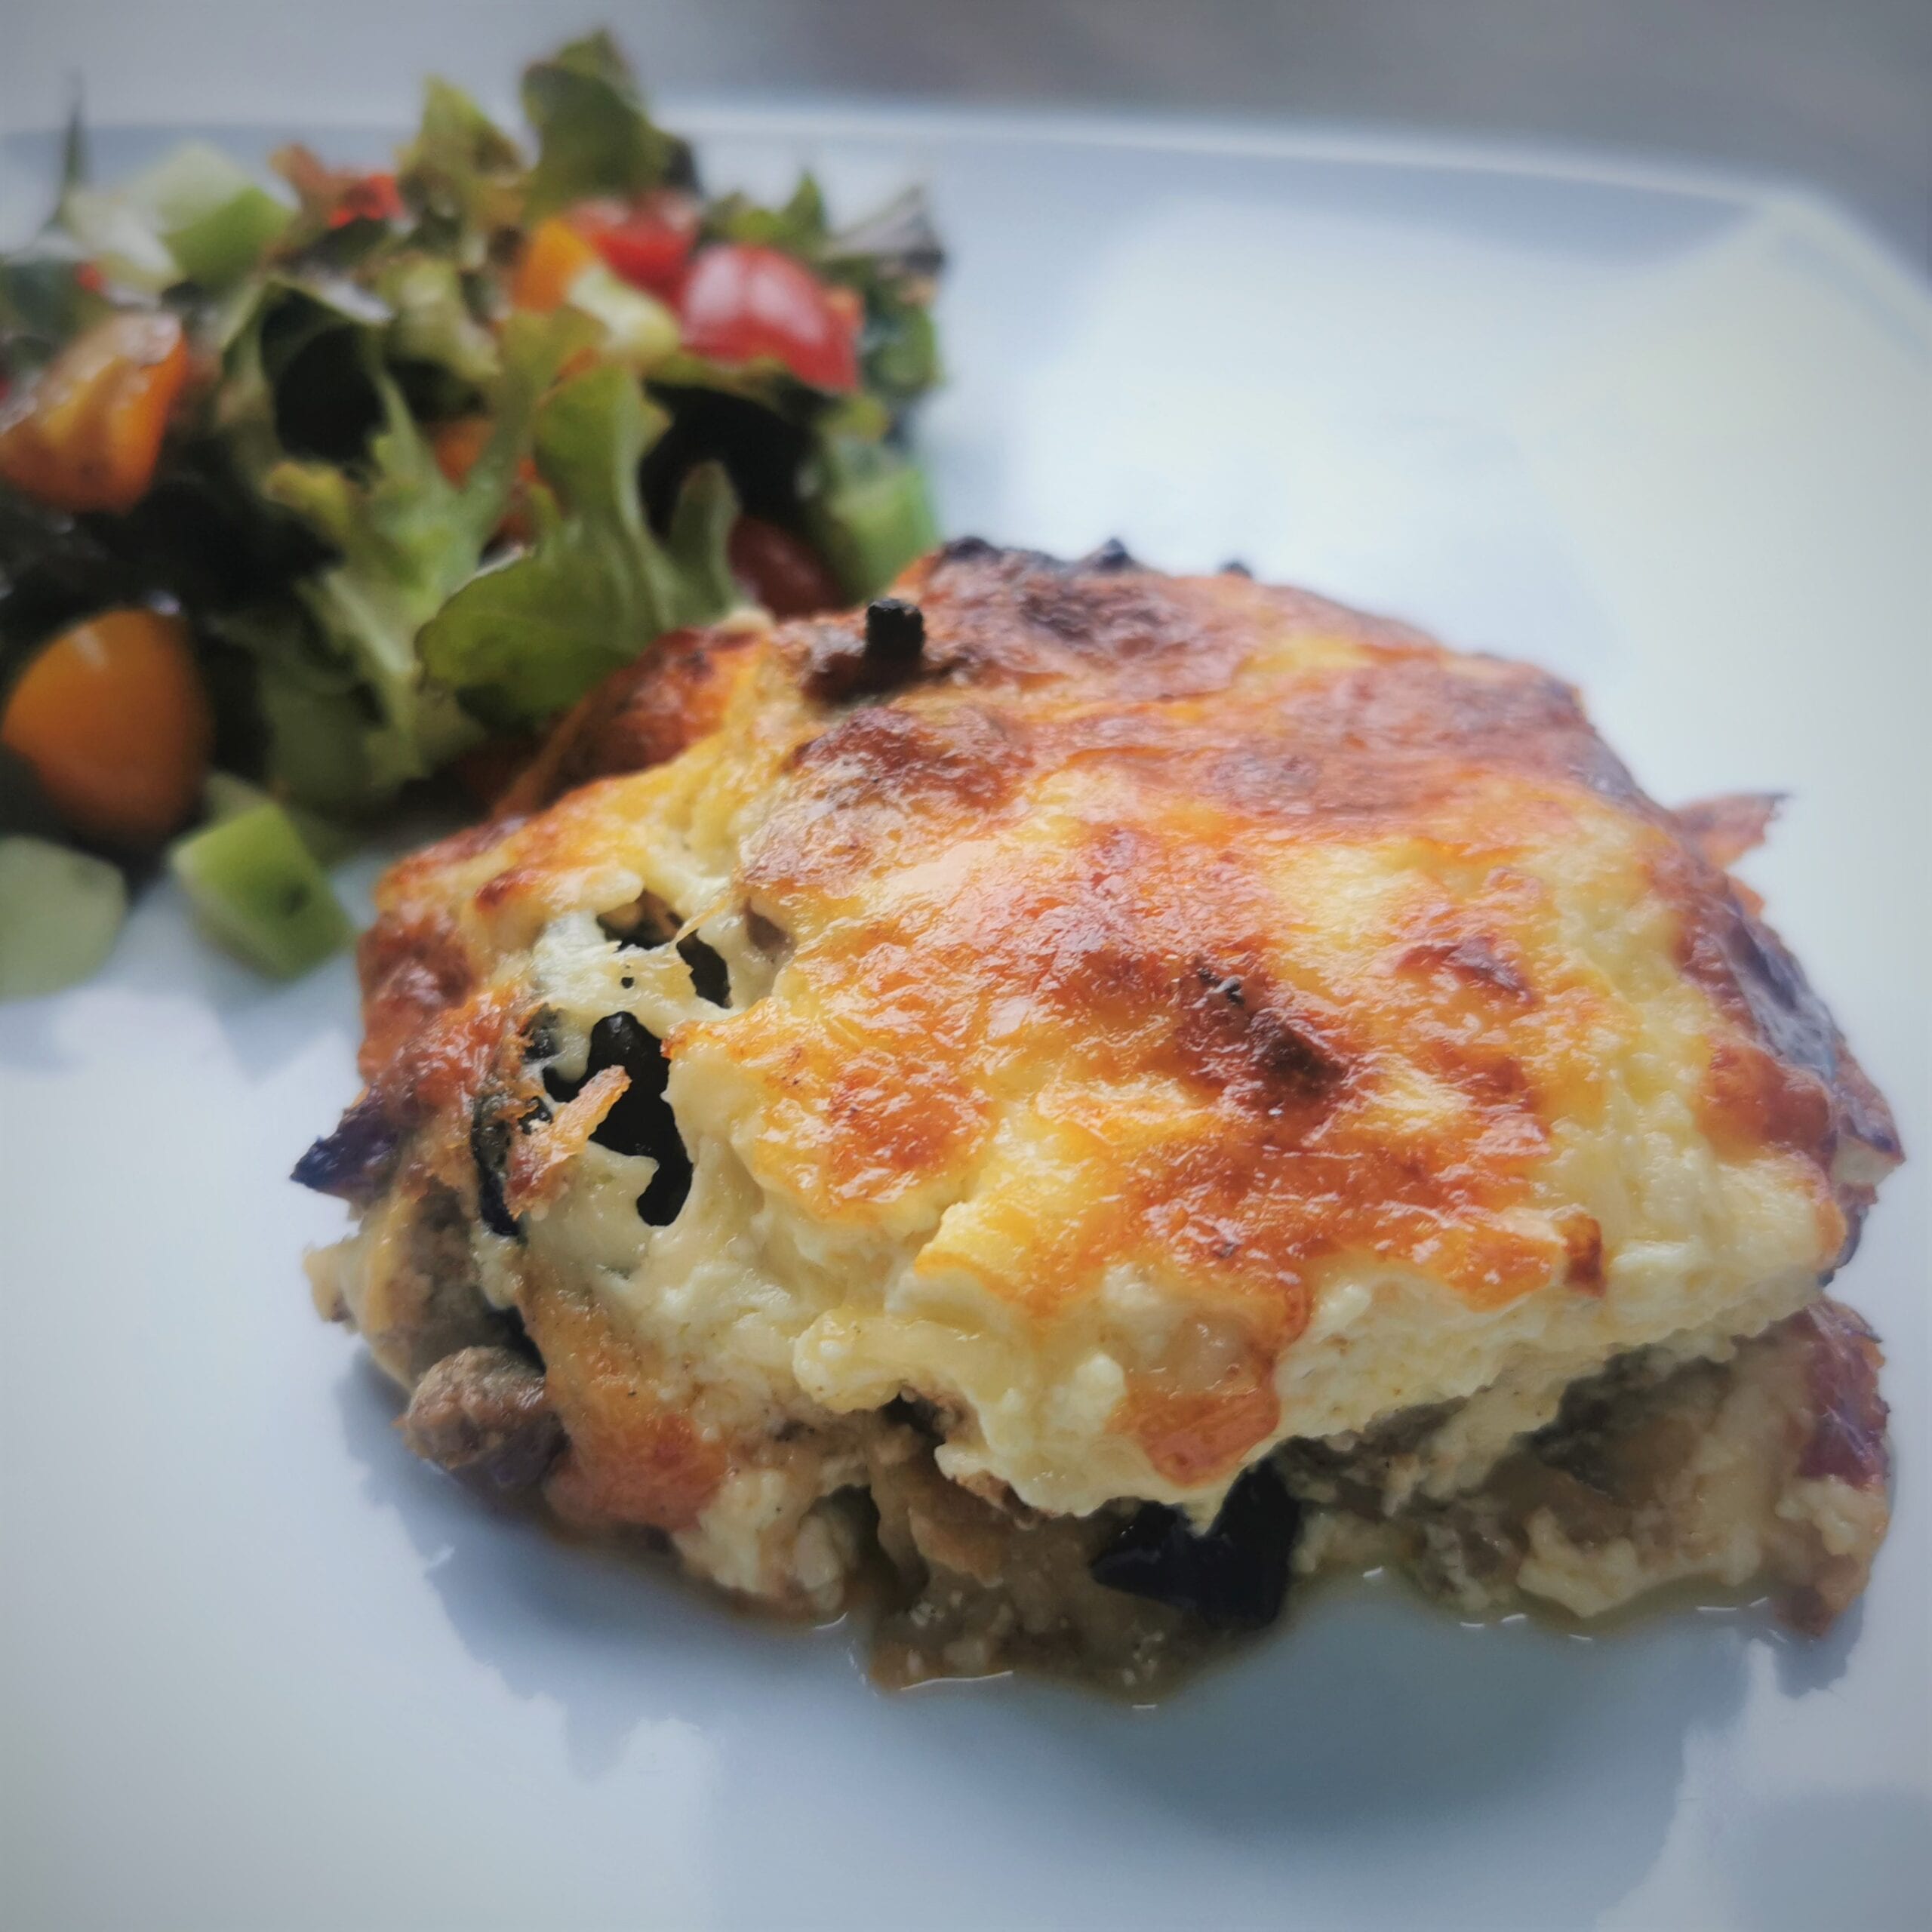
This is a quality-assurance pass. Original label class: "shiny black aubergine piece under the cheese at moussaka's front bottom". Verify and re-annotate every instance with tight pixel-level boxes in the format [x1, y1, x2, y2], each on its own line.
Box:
[1090, 1463, 1302, 1631]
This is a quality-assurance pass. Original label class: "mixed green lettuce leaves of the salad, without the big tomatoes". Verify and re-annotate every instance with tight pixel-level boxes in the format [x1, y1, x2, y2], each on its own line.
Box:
[0, 33, 939, 861]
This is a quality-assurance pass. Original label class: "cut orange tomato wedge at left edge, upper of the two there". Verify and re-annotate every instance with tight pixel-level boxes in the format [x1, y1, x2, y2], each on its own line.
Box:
[0, 311, 187, 510]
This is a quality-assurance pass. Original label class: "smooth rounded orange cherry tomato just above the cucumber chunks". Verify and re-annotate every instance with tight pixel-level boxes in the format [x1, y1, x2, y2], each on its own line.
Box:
[0, 611, 214, 848]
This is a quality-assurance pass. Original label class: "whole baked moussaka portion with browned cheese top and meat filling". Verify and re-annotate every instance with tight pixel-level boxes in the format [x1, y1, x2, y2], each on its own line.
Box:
[300, 541, 1897, 1681]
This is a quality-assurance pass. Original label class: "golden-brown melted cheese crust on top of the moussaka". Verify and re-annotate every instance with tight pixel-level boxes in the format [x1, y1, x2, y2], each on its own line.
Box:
[336, 545, 1895, 1537]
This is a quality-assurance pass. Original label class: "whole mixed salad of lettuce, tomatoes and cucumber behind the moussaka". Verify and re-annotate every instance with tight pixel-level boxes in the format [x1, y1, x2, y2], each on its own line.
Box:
[0, 35, 941, 997]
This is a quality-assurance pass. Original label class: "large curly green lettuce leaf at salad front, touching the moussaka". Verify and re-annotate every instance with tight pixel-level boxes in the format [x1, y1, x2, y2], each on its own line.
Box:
[421, 367, 736, 727]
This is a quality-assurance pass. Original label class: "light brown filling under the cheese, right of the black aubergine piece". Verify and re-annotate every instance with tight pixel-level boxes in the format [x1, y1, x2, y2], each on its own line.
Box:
[1287, 1300, 1887, 1632]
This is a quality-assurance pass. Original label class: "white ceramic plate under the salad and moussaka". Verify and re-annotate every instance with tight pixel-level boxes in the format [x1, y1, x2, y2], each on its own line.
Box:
[0, 116, 1932, 1932]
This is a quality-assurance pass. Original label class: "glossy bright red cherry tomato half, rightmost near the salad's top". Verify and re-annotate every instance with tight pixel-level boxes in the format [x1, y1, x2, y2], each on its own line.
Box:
[680, 242, 860, 389]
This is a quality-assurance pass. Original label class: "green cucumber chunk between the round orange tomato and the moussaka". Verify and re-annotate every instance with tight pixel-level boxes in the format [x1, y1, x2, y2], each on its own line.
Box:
[168, 804, 352, 980]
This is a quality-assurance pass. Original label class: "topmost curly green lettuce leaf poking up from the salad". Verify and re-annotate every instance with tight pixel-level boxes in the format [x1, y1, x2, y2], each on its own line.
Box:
[521, 33, 691, 220]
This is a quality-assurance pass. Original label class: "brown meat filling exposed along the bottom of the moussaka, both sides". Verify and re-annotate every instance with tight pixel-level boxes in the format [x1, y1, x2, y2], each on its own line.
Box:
[328, 1167, 1887, 1694]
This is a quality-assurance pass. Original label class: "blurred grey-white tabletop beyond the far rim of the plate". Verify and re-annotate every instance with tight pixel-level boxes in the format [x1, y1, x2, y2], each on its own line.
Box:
[0, 0, 1932, 266]
